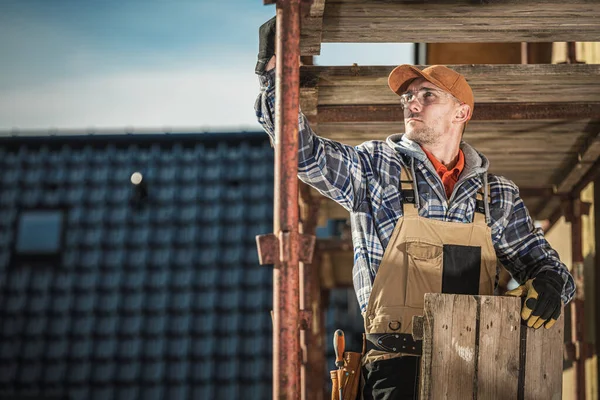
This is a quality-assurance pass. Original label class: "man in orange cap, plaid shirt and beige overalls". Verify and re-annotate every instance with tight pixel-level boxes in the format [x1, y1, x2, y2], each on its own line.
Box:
[255, 19, 575, 399]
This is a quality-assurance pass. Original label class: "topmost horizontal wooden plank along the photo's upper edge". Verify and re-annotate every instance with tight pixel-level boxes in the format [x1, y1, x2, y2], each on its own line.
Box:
[323, 0, 600, 43]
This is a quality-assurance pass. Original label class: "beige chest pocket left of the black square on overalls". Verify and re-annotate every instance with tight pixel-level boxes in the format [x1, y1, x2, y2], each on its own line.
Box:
[405, 241, 444, 308]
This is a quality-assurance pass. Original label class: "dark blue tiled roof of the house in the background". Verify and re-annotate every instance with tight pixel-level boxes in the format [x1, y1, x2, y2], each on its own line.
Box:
[0, 133, 362, 400]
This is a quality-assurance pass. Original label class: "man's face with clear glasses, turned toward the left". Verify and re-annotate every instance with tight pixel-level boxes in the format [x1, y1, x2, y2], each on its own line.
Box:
[404, 78, 459, 144]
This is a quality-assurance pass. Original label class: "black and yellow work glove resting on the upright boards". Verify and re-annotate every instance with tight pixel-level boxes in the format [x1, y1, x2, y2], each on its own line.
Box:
[506, 271, 565, 329]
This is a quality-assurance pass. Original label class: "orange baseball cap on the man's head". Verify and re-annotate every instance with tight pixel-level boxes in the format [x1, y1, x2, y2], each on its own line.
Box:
[388, 64, 475, 116]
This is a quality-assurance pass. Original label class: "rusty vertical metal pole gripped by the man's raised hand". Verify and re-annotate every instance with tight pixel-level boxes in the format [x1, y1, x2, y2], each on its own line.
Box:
[273, 0, 300, 399]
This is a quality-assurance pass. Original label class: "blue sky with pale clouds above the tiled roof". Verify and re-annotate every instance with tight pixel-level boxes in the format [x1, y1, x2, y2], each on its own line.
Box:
[0, 0, 413, 134]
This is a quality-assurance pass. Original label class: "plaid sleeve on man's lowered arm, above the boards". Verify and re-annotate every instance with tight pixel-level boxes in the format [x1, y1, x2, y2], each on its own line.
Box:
[495, 182, 575, 304]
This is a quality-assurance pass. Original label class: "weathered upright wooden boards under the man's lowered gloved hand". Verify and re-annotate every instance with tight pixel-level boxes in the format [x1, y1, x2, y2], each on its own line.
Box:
[420, 293, 564, 400]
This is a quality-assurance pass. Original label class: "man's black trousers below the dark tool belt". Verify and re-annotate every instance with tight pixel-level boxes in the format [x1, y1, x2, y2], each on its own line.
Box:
[362, 356, 421, 400]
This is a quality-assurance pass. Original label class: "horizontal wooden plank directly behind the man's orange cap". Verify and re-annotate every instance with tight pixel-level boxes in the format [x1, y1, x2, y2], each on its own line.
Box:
[301, 64, 600, 104]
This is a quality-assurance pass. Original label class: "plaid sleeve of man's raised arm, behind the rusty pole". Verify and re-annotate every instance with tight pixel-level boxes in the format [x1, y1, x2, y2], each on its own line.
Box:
[254, 69, 370, 211]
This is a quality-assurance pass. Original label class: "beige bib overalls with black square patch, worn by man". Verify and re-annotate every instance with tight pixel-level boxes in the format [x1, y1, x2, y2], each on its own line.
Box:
[363, 168, 496, 365]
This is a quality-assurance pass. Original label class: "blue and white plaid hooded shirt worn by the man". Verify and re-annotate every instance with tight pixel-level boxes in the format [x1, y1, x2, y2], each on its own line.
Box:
[255, 70, 575, 313]
